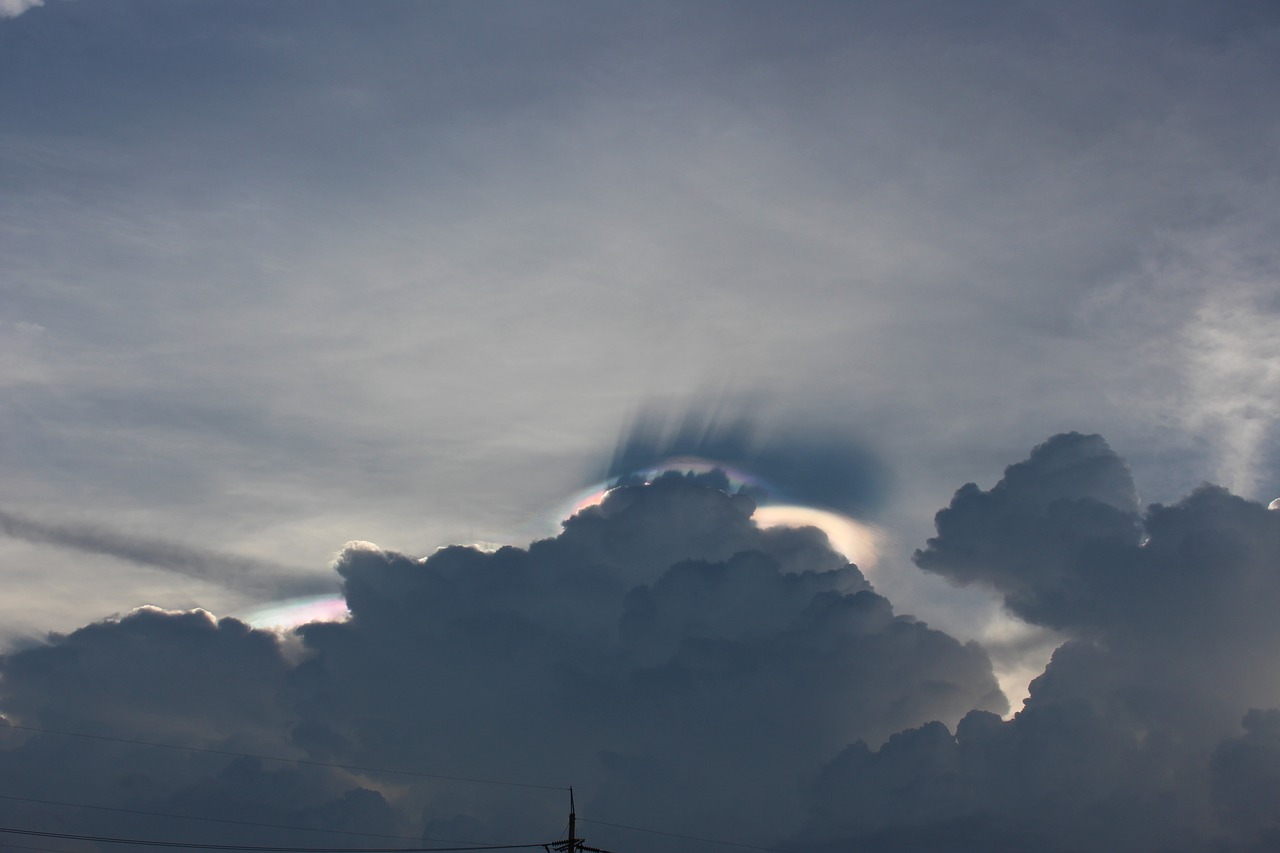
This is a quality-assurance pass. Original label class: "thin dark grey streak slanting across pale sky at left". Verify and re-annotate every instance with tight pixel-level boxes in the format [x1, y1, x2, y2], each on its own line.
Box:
[0, 511, 333, 597]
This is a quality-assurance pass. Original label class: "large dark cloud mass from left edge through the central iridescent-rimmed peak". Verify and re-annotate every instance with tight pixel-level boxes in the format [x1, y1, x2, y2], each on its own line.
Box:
[0, 475, 1005, 849]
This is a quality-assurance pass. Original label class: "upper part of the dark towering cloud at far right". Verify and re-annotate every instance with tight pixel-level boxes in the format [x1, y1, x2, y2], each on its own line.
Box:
[915, 433, 1280, 722]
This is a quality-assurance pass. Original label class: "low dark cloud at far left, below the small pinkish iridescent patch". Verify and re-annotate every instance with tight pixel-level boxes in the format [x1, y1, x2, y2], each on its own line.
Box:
[0, 608, 396, 845]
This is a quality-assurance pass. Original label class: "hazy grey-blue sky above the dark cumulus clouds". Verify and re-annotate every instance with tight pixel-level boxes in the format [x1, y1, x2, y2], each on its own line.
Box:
[0, 0, 1280, 845]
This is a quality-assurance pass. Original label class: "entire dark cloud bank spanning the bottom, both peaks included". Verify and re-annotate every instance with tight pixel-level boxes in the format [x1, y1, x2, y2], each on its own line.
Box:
[0, 434, 1280, 853]
